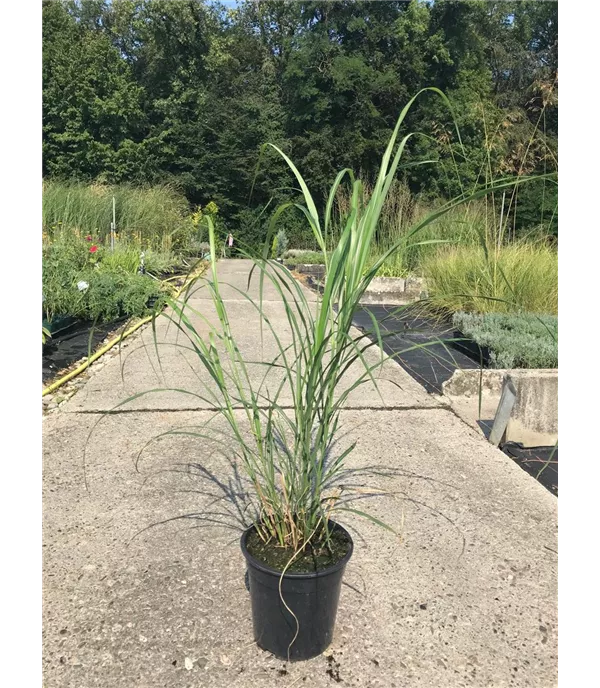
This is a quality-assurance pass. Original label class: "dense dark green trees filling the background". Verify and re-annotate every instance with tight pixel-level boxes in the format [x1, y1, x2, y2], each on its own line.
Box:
[42, 0, 558, 248]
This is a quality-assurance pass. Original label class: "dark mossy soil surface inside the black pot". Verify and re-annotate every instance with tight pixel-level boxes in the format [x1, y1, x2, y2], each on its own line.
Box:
[246, 528, 350, 573]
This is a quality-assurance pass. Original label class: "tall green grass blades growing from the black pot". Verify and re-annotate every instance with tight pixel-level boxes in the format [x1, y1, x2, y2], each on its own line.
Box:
[122, 89, 548, 568]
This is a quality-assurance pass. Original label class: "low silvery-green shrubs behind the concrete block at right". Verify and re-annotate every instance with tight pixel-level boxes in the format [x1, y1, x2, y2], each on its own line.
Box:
[452, 312, 558, 368]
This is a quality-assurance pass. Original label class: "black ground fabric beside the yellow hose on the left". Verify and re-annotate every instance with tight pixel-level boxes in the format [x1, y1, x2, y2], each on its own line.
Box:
[41, 318, 127, 383]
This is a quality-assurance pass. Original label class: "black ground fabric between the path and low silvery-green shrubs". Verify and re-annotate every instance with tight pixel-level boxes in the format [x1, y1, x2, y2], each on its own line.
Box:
[353, 303, 479, 394]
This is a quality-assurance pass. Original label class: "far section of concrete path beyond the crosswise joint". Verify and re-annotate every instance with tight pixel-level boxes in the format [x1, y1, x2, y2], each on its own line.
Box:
[64, 260, 440, 412]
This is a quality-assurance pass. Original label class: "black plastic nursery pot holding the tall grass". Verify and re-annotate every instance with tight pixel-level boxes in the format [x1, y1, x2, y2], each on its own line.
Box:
[241, 521, 354, 661]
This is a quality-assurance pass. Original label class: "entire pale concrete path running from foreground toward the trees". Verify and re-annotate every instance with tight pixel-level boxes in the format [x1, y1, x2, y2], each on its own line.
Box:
[42, 261, 558, 688]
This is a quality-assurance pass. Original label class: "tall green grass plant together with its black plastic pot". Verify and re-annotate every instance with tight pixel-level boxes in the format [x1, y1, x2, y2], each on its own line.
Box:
[113, 89, 548, 660]
